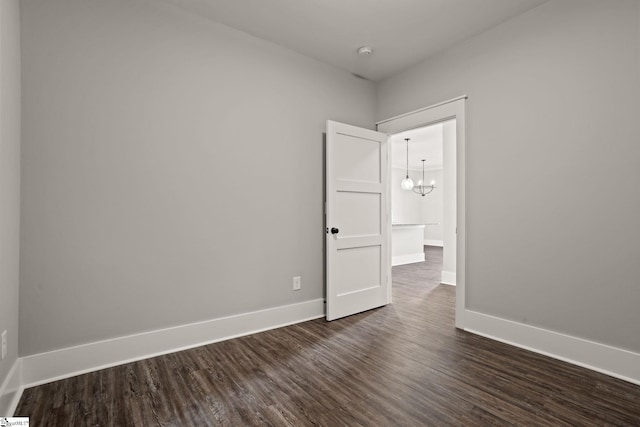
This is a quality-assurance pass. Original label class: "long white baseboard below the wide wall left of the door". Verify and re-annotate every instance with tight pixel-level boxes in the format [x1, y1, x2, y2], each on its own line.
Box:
[21, 299, 324, 388]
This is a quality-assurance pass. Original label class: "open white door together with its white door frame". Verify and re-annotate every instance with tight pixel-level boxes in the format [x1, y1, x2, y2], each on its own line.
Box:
[325, 97, 466, 329]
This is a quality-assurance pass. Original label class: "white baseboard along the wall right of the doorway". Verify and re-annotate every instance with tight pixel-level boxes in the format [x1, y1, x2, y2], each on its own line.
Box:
[464, 310, 640, 385]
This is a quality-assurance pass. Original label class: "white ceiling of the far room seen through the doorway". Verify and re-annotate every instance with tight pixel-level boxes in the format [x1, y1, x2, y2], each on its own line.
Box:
[390, 123, 443, 171]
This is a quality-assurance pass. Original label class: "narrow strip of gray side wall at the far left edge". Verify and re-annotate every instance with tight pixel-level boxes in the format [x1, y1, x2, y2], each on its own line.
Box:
[0, 0, 20, 388]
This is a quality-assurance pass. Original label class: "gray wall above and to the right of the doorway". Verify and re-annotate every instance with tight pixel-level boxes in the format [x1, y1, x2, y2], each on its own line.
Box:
[377, 0, 640, 351]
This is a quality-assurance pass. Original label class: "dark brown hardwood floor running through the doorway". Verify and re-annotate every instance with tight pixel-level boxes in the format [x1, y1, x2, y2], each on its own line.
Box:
[16, 248, 640, 426]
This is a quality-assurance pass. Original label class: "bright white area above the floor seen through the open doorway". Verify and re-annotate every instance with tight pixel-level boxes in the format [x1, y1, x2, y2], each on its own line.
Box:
[389, 119, 456, 292]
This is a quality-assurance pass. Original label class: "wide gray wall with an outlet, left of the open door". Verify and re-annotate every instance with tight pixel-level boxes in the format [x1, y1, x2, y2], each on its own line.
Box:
[20, 0, 375, 355]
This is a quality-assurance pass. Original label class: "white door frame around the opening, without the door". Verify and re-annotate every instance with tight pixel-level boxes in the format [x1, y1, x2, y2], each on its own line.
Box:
[376, 95, 467, 329]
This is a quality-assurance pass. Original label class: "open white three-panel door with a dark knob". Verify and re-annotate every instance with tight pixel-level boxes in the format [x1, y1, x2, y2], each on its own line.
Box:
[326, 121, 391, 320]
